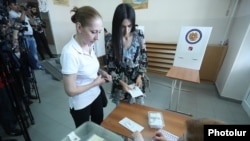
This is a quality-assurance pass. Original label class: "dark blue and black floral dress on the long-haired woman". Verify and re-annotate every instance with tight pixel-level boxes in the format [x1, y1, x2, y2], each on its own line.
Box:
[106, 30, 148, 104]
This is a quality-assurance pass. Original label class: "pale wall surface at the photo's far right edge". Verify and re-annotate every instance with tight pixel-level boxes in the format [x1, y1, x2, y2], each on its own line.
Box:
[216, 0, 250, 101]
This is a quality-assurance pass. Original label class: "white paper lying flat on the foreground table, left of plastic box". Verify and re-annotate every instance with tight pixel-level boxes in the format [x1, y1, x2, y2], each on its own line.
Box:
[119, 117, 144, 132]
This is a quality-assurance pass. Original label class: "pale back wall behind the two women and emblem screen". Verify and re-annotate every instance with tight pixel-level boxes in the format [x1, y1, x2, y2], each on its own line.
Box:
[48, 0, 232, 54]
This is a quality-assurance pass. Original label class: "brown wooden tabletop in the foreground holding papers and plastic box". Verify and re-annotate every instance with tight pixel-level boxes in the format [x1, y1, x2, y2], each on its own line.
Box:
[101, 102, 190, 141]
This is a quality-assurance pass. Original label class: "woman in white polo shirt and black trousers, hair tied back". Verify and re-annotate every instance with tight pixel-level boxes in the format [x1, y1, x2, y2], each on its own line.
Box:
[60, 6, 112, 127]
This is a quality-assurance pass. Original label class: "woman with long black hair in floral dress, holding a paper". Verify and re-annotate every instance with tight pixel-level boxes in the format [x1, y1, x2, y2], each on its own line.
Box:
[106, 3, 148, 104]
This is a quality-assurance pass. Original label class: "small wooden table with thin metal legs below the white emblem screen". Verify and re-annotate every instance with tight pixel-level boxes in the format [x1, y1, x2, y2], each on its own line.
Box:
[166, 66, 200, 115]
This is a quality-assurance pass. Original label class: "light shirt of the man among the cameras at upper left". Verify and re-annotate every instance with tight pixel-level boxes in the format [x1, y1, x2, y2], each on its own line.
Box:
[9, 10, 33, 35]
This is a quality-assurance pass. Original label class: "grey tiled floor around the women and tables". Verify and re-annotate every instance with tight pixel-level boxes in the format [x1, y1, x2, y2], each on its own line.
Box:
[0, 70, 250, 141]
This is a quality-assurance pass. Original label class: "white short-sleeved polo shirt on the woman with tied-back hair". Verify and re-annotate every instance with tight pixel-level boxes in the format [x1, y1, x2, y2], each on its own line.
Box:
[60, 36, 100, 110]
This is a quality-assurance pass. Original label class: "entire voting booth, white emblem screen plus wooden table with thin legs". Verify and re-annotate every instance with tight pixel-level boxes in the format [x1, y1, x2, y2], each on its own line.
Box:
[166, 26, 212, 115]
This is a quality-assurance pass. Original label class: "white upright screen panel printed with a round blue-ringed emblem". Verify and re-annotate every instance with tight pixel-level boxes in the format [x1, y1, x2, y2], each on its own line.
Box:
[173, 26, 212, 70]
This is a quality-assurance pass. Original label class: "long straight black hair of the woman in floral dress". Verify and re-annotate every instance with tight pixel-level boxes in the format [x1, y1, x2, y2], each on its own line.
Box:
[112, 3, 135, 63]
